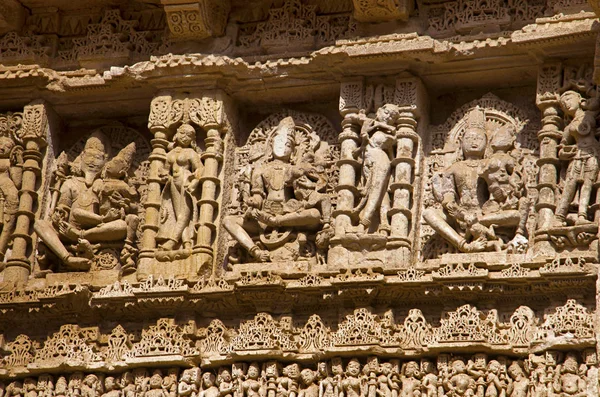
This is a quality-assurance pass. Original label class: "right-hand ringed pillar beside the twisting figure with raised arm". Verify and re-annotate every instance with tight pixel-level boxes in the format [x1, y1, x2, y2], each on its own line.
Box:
[388, 77, 425, 265]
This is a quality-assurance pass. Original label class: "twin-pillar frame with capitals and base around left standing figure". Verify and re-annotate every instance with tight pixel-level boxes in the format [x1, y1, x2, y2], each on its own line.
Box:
[137, 91, 230, 280]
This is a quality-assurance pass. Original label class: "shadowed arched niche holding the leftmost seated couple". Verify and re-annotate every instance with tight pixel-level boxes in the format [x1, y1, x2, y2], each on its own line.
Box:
[34, 123, 150, 275]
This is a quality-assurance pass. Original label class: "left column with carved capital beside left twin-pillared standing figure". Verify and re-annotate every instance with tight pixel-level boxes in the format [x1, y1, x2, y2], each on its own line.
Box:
[140, 95, 172, 260]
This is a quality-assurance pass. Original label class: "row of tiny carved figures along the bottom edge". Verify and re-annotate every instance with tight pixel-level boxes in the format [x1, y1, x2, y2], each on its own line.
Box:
[2, 349, 598, 397]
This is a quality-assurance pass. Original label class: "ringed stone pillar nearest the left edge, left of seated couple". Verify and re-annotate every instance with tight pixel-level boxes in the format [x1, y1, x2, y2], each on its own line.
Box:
[4, 102, 51, 284]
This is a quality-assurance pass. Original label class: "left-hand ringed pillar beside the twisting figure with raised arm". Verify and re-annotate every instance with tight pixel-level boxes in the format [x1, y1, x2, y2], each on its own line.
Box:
[334, 80, 363, 236]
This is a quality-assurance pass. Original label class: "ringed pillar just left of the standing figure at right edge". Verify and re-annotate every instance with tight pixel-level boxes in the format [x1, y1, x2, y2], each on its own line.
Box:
[535, 63, 562, 255]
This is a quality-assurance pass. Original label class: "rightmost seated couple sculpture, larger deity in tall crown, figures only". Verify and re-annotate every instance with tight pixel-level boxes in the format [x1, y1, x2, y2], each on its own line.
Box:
[423, 108, 529, 252]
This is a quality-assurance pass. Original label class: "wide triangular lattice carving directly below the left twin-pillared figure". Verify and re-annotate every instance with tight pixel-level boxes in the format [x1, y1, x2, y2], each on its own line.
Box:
[133, 318, 198, 357]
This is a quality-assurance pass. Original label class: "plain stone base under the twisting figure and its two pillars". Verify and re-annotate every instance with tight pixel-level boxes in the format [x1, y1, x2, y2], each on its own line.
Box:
[327, 234, 410, 271]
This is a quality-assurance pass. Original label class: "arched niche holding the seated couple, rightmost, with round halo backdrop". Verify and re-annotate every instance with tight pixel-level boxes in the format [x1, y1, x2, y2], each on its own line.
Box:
[421, 94, 537, 259]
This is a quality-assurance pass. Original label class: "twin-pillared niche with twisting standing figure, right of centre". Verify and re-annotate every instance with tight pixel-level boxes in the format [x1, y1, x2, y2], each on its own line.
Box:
[328, 76, 426, 269]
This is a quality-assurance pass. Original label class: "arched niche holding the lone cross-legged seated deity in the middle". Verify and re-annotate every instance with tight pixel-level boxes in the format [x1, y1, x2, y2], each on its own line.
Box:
[223, 111, 339, 266]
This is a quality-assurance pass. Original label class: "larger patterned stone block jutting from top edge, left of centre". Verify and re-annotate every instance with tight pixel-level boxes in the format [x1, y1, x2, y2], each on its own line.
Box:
[161, 0, 231, 40]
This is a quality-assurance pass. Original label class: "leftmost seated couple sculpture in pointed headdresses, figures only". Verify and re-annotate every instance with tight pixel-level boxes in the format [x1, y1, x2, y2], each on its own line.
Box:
[34, 132, 139, 273]
